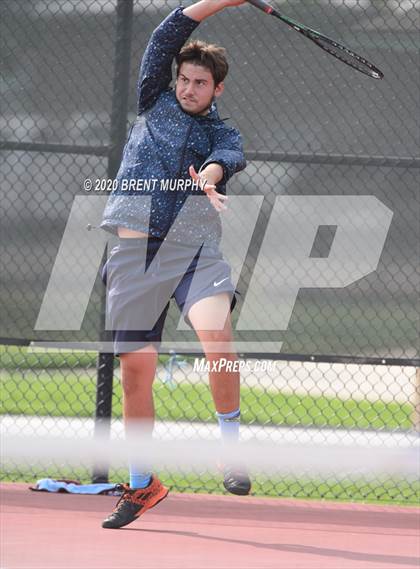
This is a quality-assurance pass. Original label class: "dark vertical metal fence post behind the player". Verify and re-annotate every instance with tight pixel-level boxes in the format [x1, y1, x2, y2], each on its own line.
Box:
[92, 0, 133, 483]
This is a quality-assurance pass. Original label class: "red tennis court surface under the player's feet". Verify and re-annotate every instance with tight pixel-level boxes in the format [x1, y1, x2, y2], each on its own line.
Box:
[0, 484, 420, 569]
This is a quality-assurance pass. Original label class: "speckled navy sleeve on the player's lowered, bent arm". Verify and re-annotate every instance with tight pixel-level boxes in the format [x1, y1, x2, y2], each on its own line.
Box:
[200, 126, 246, 185]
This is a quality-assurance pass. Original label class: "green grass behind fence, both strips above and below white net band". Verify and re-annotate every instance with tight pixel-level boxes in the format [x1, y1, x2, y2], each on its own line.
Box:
[0, 347, 420, 505]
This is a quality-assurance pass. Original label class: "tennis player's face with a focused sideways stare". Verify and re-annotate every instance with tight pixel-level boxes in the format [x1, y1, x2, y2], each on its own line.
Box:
[175, 62, 223, 115]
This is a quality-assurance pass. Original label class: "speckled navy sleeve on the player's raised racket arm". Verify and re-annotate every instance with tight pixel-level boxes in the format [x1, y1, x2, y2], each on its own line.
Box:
[137, 7, 200, 115]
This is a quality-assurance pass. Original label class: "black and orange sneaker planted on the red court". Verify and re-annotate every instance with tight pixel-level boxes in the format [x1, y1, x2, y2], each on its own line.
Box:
[102, 475, 169, 529]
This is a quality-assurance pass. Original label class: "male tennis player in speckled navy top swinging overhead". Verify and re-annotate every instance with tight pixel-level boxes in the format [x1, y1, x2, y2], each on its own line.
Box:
[101, 0, 251, 528]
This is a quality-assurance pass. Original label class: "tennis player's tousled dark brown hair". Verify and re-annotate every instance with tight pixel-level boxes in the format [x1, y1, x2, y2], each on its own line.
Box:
[176, 40, 229, 85]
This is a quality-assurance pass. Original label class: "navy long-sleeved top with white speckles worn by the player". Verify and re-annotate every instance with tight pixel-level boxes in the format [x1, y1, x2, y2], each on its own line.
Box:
[101, 7, 246, 246]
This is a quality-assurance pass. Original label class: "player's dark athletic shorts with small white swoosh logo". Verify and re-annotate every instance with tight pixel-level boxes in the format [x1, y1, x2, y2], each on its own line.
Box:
[102, 237, 237, 356]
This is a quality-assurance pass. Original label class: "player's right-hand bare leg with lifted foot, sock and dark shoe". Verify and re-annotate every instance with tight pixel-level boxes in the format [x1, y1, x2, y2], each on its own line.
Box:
[188, 293, 251, 495]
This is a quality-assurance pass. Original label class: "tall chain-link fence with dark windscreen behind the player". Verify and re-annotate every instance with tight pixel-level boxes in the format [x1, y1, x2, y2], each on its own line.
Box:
[0, 0, 420, 501]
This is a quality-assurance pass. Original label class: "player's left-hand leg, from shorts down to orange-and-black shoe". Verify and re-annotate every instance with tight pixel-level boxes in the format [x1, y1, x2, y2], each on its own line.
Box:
[102, 233, 169, 529]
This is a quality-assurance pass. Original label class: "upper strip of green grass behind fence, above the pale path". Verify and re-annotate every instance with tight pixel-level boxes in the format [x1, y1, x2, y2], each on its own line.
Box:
[0, 368, 412, 429]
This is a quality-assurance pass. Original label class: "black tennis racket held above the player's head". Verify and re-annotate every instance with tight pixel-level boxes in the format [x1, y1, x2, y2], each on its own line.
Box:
[247, 0, 384, 79]
